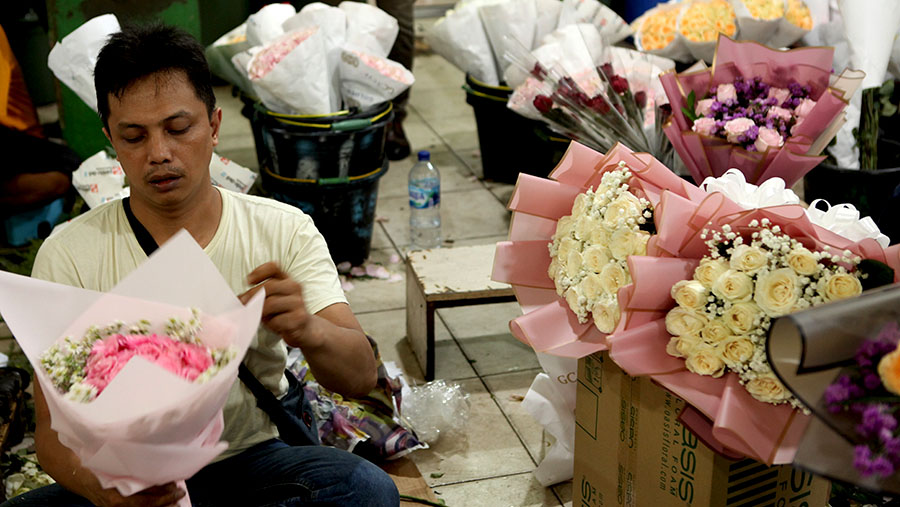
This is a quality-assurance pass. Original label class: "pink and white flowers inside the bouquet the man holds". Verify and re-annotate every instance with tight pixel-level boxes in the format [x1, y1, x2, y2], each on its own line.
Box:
[41, 310, 237, 403]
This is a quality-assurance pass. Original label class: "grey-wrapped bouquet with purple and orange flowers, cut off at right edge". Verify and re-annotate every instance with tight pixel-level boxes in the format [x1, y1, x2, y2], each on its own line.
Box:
[767, 285, 900, 495]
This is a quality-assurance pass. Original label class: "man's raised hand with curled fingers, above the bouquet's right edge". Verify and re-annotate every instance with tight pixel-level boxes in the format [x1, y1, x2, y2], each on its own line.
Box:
[239, 262, 321, 348]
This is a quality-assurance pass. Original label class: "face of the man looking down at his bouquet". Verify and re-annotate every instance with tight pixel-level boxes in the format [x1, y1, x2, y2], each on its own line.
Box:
[104, 71, 222, 211]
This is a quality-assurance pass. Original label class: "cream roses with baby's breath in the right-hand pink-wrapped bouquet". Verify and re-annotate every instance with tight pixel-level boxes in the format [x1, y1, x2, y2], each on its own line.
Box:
[666, 219, 862, 410]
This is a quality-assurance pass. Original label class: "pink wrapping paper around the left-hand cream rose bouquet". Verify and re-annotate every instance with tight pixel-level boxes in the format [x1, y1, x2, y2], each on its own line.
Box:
[492, 142, 706, 357]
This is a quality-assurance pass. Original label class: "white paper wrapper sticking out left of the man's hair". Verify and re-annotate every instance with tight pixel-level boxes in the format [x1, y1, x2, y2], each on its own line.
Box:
[47, 14, 121, 111]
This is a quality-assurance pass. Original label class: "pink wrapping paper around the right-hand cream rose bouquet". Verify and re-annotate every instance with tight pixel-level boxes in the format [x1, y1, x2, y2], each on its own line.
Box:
[607, 187, 900, 464]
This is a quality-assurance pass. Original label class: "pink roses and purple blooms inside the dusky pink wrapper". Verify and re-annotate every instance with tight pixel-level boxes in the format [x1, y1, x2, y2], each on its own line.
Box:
[682, 76, 816, 152]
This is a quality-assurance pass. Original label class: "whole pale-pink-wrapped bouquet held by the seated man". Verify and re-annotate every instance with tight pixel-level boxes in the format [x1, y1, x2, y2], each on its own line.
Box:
[0, 231, 264, 505]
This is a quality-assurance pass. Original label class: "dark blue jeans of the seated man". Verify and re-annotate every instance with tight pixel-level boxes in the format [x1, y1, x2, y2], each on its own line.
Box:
[0, 440, 400, 507]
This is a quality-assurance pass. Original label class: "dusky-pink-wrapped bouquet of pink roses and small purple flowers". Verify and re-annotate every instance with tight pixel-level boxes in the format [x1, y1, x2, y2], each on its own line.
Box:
[660, 36, 862, 186]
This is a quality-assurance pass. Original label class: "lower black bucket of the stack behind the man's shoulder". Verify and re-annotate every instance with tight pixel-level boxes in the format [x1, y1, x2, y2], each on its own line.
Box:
[260, 158, 389, 266]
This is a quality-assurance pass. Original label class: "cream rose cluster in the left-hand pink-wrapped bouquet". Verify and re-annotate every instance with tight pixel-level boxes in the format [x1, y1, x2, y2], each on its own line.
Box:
[548, 162, 653, 333]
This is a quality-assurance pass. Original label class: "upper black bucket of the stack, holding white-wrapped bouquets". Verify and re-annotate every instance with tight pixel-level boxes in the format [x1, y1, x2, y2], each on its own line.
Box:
[241, 94, 393, 180]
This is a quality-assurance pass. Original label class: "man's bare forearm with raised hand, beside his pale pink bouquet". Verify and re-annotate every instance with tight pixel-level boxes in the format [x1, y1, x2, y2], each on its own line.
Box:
[240, 262, 378, 397]
